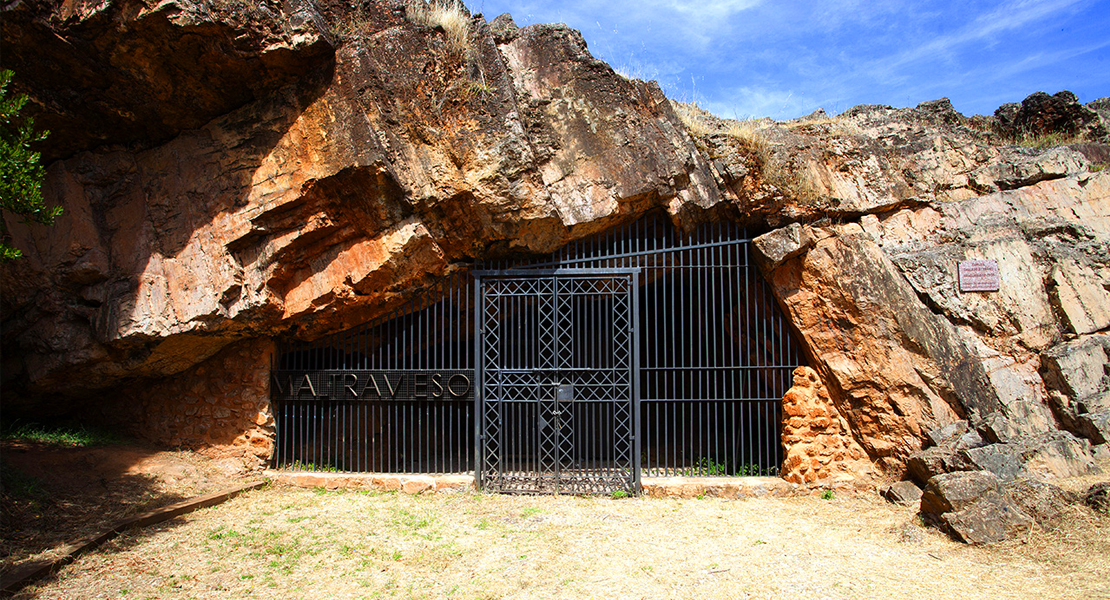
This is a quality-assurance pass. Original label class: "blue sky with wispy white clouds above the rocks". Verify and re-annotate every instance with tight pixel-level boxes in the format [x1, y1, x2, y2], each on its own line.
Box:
[465, 0, 1110, 119]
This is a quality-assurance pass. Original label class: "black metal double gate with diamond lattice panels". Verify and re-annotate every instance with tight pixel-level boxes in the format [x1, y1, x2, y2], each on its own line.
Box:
[475, 268, 639, 494]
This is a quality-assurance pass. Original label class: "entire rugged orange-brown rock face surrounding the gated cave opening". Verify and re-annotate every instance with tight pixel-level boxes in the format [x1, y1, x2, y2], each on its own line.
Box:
[0, 0, 1110, 484]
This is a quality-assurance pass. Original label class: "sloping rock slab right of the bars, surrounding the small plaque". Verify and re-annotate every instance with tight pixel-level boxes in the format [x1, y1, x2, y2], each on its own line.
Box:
[756, 172, 1110, 470]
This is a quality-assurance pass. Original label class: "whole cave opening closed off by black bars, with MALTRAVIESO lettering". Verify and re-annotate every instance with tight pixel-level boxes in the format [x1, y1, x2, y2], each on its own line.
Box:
[271, 214, 805, 485]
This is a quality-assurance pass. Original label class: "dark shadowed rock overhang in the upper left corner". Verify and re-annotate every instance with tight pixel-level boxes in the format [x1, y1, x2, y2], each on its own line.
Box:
[3, 0, 332, 162]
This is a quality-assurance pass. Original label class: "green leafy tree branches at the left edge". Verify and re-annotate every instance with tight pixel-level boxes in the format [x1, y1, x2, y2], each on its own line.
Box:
[0, 71, 62, 261]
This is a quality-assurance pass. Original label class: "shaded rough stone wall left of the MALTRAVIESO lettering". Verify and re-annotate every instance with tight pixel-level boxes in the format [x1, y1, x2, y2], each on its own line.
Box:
[102, 338, 274, 467]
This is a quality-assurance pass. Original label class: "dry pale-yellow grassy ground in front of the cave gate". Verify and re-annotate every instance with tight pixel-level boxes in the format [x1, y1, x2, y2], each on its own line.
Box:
[4, 448, 1110, 600]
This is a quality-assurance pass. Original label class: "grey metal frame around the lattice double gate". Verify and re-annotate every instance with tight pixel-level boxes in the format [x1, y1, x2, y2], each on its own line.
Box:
[471, 267, 643, 496]
